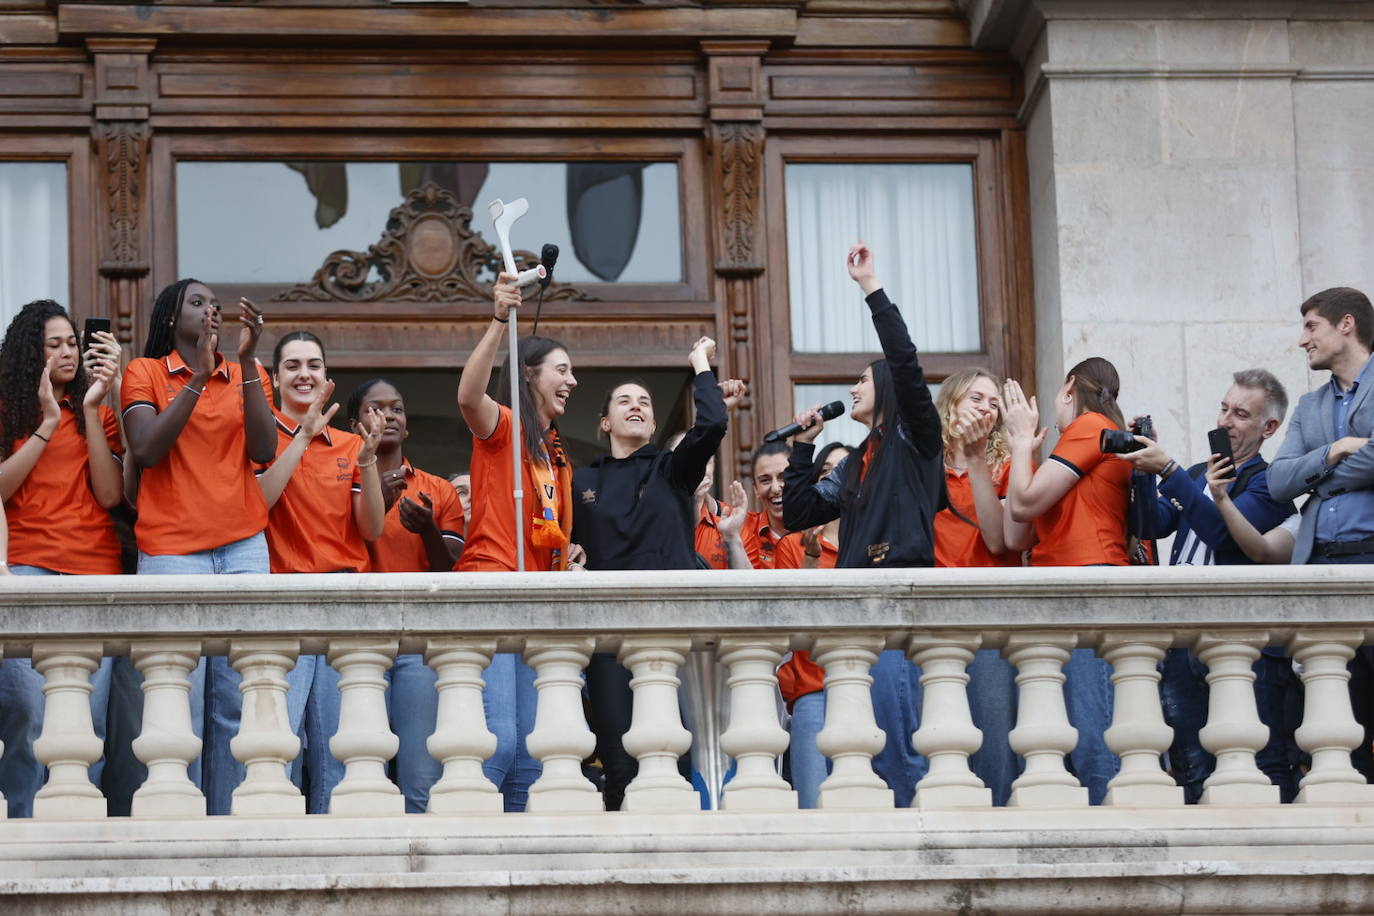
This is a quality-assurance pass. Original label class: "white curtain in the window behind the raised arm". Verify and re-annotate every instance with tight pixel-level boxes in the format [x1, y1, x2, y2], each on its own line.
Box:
[785, 163, 981, 353]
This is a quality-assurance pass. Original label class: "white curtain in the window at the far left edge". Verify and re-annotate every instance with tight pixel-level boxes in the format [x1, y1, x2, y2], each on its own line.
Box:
[0, 162, 71, 334]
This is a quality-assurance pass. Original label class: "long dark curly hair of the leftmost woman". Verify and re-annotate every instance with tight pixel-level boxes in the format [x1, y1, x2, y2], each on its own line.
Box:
[0, 299, 89, 457]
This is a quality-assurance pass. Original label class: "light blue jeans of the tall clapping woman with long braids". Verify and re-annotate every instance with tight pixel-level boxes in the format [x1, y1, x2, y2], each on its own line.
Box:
[133, 531, 271, 814]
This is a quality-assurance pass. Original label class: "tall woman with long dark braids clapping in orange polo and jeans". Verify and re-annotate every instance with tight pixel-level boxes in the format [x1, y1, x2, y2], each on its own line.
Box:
[120, 279, 276, 814]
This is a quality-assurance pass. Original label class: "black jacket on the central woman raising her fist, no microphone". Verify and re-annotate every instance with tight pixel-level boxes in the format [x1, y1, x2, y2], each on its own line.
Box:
[573, 372, 725, 570]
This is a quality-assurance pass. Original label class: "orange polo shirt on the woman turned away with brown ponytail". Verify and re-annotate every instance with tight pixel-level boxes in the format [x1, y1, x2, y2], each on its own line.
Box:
[1031, 411, 1132, 566]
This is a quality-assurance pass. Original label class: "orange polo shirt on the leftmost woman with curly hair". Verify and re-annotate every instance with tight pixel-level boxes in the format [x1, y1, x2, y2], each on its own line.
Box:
[4, 398, 124, 575]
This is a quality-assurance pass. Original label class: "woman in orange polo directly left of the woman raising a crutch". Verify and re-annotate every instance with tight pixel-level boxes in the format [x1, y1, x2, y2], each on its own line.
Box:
[348, 379, 463, 813]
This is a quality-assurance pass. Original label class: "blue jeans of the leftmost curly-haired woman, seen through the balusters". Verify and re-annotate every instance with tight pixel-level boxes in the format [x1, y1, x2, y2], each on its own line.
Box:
[0, 564, 113, 817]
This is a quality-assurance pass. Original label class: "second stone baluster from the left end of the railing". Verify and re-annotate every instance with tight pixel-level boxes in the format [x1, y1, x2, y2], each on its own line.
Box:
[129, 640, 205, 817]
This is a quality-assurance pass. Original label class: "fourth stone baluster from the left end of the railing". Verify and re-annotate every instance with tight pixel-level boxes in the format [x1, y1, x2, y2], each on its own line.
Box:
[328, 637, 405, 816]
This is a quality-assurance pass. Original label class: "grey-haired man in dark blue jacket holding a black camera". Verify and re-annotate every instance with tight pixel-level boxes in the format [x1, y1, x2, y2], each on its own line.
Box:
[1121, 369, 1300, 802]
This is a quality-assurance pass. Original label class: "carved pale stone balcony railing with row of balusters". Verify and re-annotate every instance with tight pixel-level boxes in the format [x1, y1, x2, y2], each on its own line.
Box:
[0, 567, 1374, 912]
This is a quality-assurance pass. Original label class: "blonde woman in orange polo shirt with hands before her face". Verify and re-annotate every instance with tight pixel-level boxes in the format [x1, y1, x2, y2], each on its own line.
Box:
[936, 368, 1035, 805]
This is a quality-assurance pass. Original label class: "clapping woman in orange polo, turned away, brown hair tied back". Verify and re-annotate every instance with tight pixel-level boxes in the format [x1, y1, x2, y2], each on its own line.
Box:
[1002, 357, 1131, 805]
